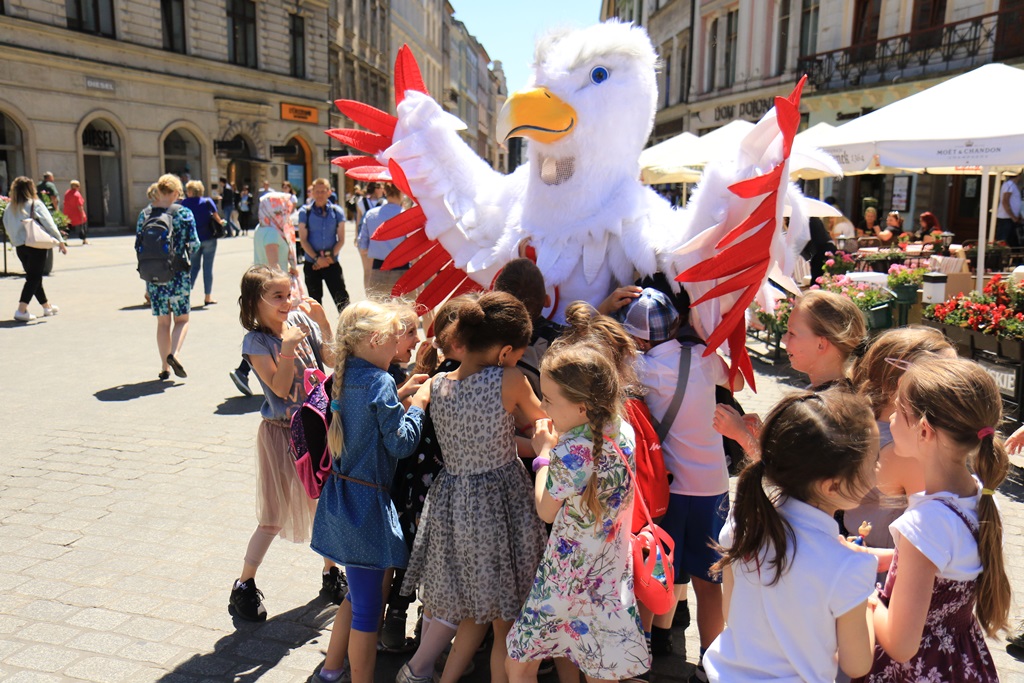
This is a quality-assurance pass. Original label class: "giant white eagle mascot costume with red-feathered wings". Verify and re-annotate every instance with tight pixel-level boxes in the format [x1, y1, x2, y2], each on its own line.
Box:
[328, 20, 840, 386]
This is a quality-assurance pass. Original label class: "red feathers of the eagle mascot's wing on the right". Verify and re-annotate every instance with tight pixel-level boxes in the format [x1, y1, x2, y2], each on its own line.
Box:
[676, 76, 807, 389]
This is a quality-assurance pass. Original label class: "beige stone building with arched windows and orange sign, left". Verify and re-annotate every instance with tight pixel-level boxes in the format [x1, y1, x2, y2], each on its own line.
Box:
[0, 0, 333, 226]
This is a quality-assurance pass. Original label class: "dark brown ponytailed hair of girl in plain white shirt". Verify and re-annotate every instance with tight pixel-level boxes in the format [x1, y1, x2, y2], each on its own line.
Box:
[713, 388, 879, 586]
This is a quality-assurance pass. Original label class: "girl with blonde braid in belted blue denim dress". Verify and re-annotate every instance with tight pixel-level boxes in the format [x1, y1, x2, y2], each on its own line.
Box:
[310, 301, 427, 683]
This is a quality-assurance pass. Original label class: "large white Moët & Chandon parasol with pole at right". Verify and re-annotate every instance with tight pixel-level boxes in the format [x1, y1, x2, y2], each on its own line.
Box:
[823, 63, 1024, 290]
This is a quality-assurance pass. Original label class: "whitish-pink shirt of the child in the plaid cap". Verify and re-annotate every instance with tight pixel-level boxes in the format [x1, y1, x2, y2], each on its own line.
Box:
[637, 339, 729, 496]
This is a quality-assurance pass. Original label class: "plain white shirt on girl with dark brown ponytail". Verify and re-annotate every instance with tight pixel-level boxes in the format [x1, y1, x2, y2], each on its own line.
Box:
[703, 499, 878, 683]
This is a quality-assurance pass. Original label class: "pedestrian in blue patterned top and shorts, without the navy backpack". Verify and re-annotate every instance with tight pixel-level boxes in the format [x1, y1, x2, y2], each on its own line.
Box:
[135, 173, 200, 380]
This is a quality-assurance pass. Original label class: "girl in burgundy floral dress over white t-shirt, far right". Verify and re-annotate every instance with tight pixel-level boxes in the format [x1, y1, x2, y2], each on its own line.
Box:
[864, 358, 1010, 683]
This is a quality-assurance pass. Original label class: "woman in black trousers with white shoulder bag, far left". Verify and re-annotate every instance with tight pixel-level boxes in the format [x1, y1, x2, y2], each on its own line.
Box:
[3, 175, 68, 323]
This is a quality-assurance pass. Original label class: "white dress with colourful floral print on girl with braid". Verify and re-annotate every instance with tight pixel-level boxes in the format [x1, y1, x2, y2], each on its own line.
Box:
[507, 421, 650, 679]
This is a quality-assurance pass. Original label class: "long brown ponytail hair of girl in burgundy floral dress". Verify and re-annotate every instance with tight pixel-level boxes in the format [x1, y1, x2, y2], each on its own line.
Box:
[897, 358, 1010, 636]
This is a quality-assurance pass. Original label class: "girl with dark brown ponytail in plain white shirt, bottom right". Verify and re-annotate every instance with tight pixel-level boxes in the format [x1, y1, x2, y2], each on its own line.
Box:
[703, 388, 879, 683]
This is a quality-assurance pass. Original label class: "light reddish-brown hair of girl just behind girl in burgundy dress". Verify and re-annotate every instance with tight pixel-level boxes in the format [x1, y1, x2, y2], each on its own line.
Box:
[852, 326, 953, 420]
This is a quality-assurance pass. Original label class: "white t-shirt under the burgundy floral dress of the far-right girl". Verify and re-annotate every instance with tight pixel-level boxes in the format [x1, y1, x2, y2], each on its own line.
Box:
[889, 483, 981, 581]
